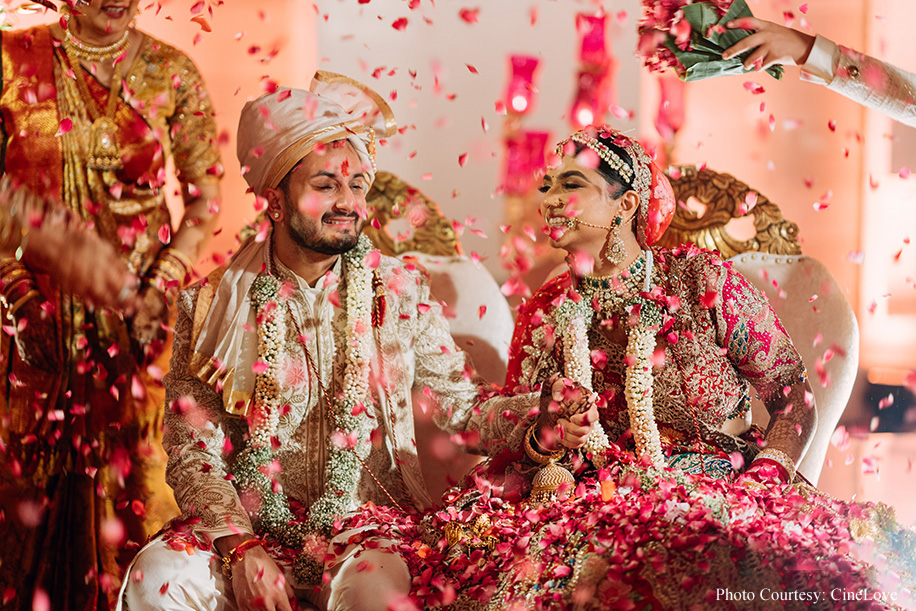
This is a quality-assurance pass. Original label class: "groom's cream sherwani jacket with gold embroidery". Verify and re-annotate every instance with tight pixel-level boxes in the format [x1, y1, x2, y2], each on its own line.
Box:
[164, 257, 537, 538]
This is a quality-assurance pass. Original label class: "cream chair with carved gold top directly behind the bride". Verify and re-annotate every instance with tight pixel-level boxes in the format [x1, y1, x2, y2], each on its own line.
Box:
[660, 166, 859, 484]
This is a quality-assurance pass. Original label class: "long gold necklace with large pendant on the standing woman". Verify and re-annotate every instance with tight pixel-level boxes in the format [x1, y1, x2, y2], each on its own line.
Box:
[64, 41, 130, 171]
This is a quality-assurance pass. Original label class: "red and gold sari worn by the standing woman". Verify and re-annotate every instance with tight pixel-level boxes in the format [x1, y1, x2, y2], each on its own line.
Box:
[0, 26, 222, 609]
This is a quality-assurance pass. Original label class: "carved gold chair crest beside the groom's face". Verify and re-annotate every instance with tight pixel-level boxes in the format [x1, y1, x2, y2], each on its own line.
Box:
[363, 172, 462, 257]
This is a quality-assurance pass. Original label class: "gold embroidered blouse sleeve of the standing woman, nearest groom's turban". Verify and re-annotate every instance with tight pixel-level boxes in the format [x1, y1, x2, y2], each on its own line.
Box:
[169, 53, 223, 183]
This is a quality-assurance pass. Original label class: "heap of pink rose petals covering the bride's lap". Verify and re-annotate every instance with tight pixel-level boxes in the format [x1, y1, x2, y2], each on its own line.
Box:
[341, 447, 916, 609]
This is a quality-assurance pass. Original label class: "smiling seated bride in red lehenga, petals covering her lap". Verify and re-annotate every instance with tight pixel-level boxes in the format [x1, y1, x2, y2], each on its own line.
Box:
[346, 127, 916, 610]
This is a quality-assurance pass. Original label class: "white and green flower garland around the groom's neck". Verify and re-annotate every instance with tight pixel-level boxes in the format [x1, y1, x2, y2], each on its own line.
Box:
[233, 236, 374, 583]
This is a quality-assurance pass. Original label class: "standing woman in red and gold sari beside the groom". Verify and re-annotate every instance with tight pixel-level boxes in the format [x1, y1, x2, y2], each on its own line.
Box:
[0, 0, 222, 610]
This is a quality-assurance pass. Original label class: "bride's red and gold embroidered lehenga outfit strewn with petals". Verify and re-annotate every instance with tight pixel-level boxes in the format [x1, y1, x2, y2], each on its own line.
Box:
[344, 128, 916, 611]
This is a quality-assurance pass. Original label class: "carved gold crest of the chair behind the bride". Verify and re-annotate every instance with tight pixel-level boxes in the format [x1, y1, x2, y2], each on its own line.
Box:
[659, 165, 801, 259]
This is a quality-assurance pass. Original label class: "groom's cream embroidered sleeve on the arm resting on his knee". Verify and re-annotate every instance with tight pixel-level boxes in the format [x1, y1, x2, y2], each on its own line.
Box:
[162, 288, 254, 539]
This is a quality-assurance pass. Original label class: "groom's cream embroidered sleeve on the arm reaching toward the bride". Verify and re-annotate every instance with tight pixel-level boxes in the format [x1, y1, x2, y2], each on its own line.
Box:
[414, 275, 538, 455]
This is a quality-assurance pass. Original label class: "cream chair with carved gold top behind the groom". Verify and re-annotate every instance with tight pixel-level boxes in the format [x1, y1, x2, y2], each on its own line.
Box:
[364, 172, 514, 500]
